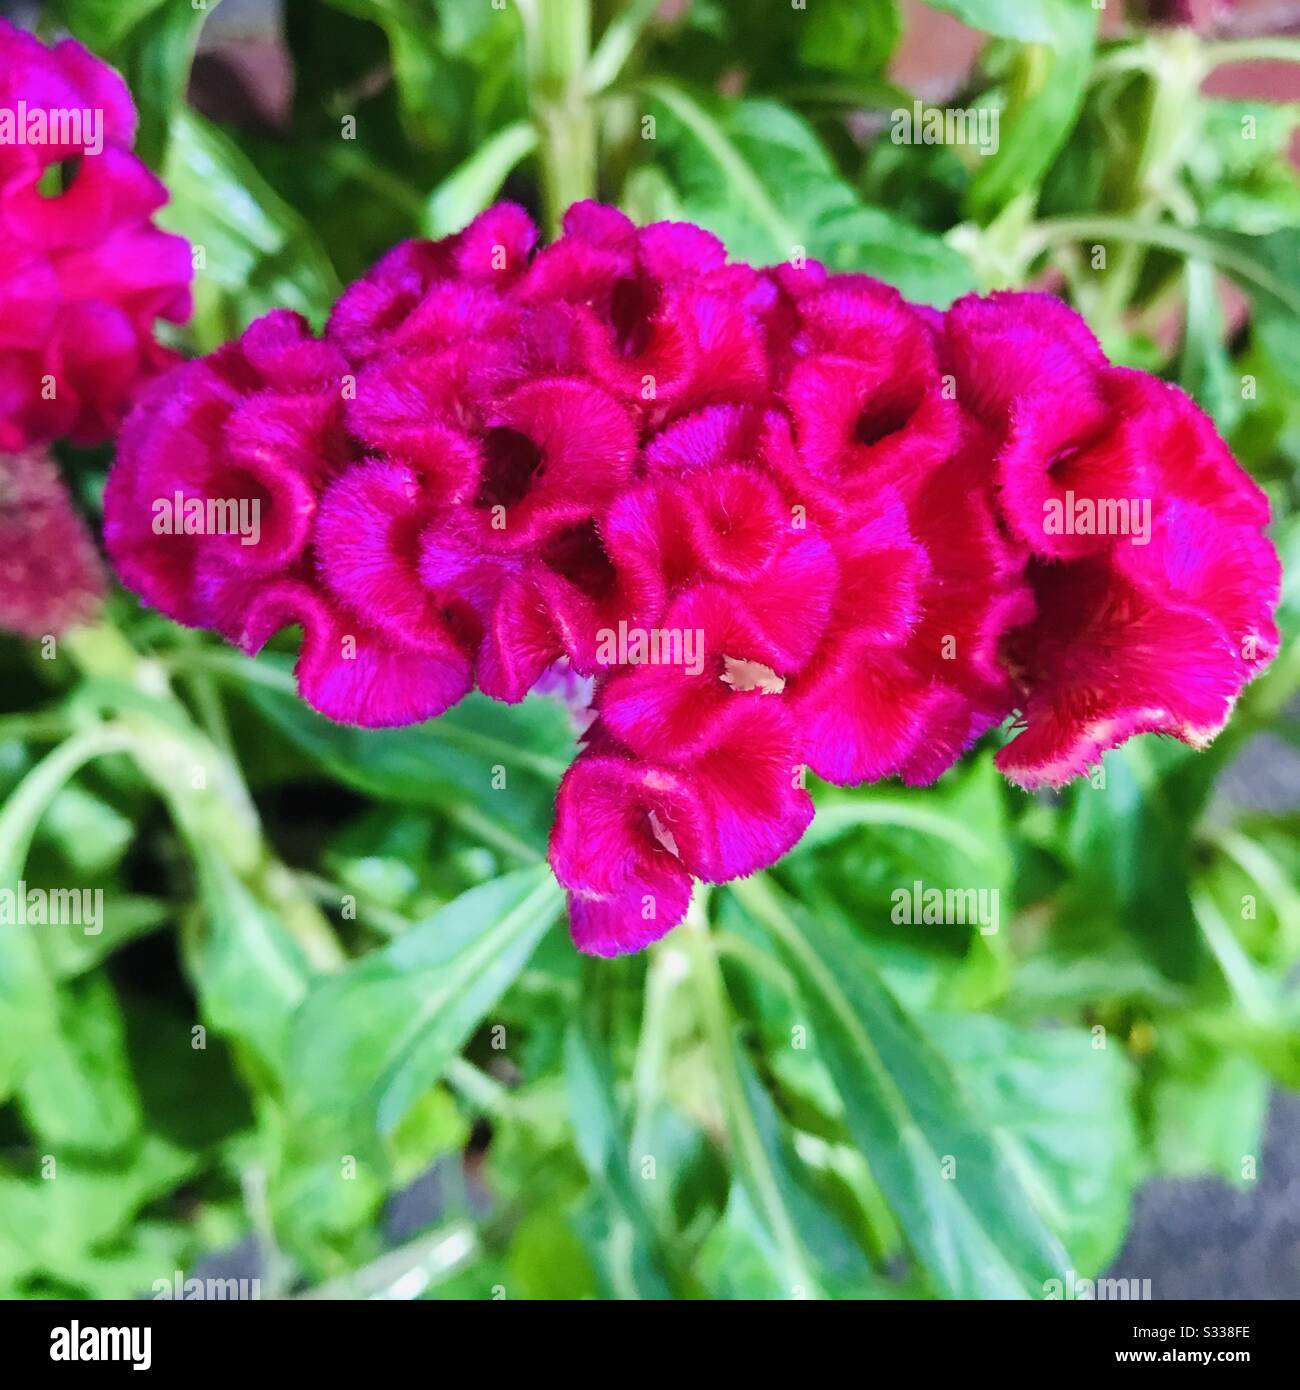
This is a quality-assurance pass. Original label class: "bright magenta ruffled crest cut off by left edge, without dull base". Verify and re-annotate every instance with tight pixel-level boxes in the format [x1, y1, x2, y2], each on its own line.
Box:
[0, 19, 192, 449]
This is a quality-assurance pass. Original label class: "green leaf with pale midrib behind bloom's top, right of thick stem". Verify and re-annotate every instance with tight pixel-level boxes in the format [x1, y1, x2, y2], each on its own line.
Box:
[644, 81, 973, 306]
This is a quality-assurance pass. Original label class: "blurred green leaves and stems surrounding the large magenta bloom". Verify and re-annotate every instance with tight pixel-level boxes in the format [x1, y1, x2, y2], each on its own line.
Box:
[0, 0, 1300, 1298]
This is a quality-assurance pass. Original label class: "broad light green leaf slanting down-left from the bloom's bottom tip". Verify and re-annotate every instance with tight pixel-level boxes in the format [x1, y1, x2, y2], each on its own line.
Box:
[285, 866, 562, 1162]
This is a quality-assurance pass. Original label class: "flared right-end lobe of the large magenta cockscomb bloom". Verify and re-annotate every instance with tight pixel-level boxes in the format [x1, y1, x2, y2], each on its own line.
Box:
[947, 295, 1281, 787]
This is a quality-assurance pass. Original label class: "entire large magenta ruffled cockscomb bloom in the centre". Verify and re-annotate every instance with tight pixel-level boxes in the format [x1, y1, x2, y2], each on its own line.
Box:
[106, 203, 1279, 955]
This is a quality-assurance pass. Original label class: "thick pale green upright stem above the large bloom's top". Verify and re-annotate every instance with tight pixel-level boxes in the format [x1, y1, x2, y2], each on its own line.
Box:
[519, 0, 596, 238]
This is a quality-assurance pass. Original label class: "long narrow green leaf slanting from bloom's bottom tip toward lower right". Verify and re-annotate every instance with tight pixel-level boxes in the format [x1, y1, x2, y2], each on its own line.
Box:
[731, 878, 1066, 1298]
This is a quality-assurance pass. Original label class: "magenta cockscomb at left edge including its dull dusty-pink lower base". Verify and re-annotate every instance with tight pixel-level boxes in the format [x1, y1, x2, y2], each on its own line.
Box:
[0, 19, 192, 637]
